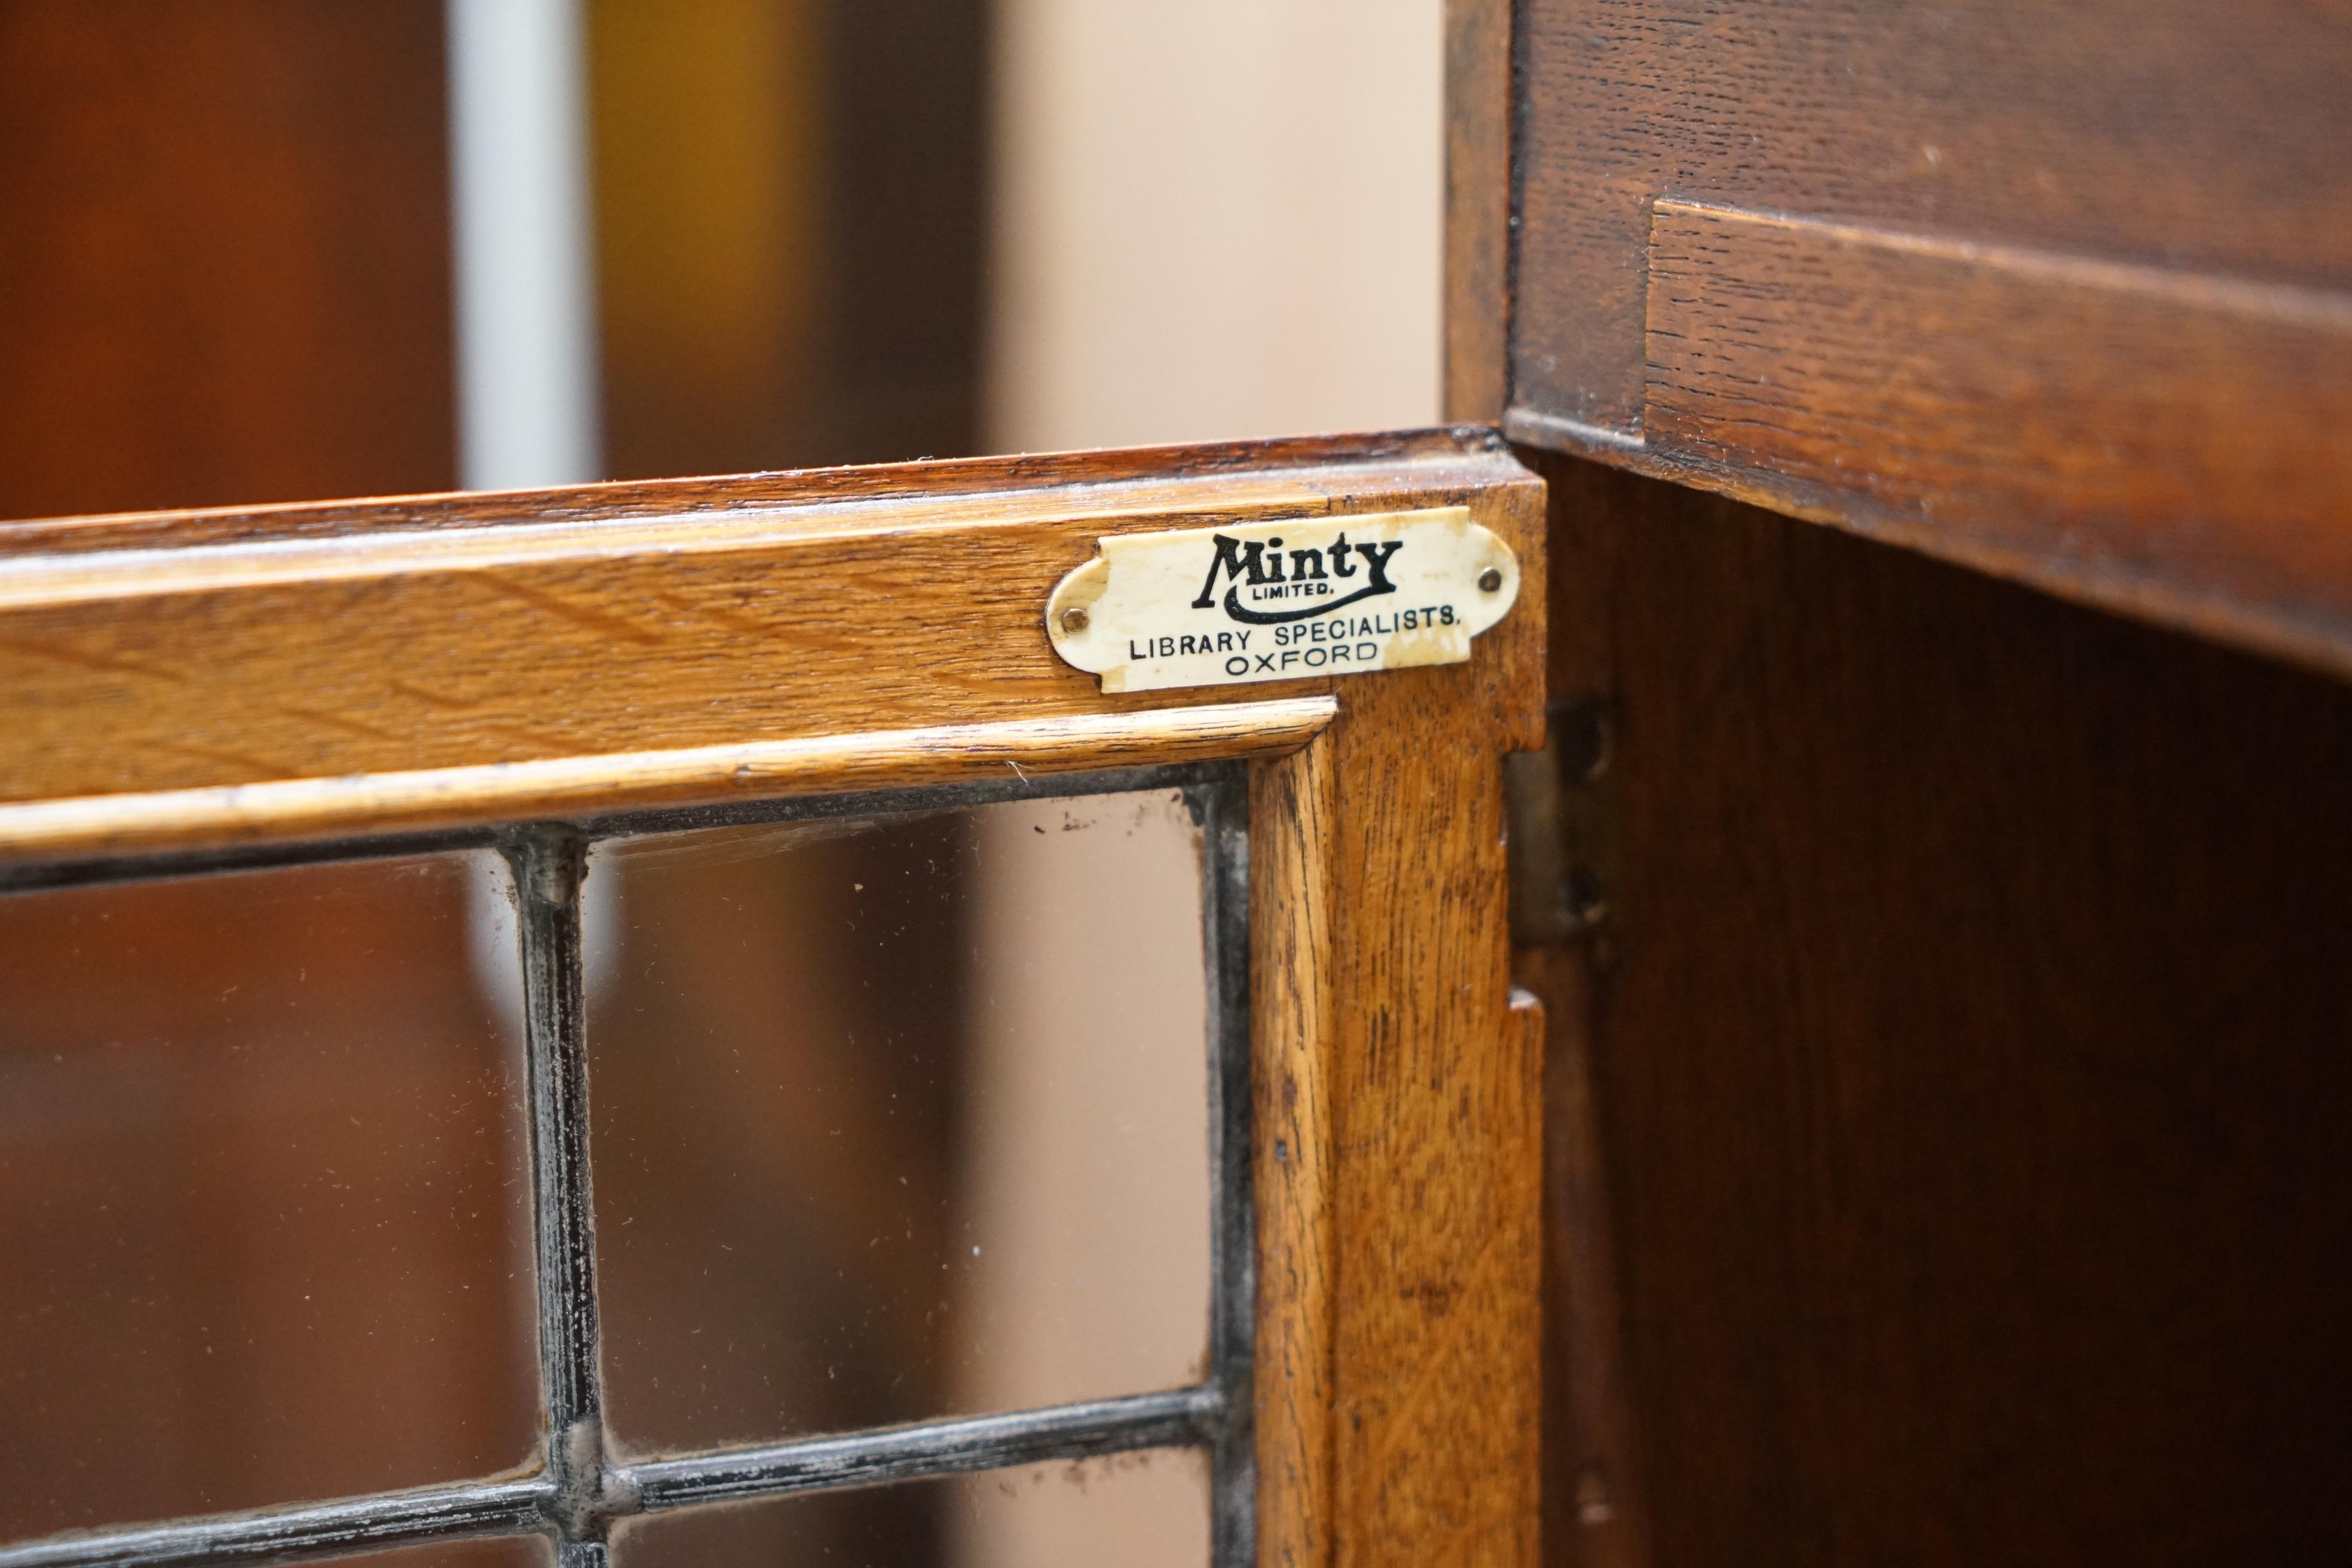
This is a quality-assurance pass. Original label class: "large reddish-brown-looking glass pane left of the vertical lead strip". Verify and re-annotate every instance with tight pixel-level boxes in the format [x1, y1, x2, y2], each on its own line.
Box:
[0, 856, 538, 1540]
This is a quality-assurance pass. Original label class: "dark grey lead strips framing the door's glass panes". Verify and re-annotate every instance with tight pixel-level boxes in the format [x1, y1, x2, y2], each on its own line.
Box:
[0, 764, 1256, 1568]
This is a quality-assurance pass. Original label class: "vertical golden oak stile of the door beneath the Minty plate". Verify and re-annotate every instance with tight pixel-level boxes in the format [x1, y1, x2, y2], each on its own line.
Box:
[1251, 439, 1545, 1568]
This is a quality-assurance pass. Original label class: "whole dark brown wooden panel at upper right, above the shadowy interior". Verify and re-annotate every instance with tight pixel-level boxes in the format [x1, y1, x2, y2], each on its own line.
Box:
[1496, 0, 2352, 672]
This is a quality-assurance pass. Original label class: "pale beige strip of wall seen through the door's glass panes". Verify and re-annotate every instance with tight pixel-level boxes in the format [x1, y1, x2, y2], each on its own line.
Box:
[950, 792, 1209, 1568]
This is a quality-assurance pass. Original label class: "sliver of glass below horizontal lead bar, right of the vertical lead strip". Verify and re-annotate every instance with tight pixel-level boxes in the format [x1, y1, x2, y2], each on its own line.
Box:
[614, 1448, 1209, 1568]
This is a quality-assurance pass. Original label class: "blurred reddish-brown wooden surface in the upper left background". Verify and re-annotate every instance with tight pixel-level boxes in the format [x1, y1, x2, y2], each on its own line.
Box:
[0, 0, 457, 517]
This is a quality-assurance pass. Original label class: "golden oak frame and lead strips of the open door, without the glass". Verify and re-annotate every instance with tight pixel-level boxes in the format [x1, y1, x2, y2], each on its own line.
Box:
[0, 430, 1545, 1568]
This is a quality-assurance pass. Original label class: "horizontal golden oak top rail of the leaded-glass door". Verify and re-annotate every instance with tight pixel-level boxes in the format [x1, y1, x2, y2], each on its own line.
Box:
[0, 433, 1524, 827]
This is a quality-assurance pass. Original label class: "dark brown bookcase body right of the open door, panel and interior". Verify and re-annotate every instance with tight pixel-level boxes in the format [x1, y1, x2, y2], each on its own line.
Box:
[1477, 12, 2352, 1568]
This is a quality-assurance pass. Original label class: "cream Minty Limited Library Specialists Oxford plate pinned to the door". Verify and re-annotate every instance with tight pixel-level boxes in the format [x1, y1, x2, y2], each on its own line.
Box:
[1045, 506, 1520, 691]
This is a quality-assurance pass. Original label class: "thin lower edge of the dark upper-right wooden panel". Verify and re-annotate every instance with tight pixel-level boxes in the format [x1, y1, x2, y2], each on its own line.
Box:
[1503, 409, 2352, 679]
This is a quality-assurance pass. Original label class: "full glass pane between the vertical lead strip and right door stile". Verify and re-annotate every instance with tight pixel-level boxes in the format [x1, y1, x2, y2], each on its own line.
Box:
[588, 792, 1209, 1453]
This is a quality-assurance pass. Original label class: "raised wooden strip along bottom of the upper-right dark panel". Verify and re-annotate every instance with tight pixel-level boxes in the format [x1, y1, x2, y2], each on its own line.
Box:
[1644, 202, 2352, 672]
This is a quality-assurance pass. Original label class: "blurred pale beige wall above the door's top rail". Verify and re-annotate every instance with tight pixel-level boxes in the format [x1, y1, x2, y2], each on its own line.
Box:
[983, 0, 1444, 451]
